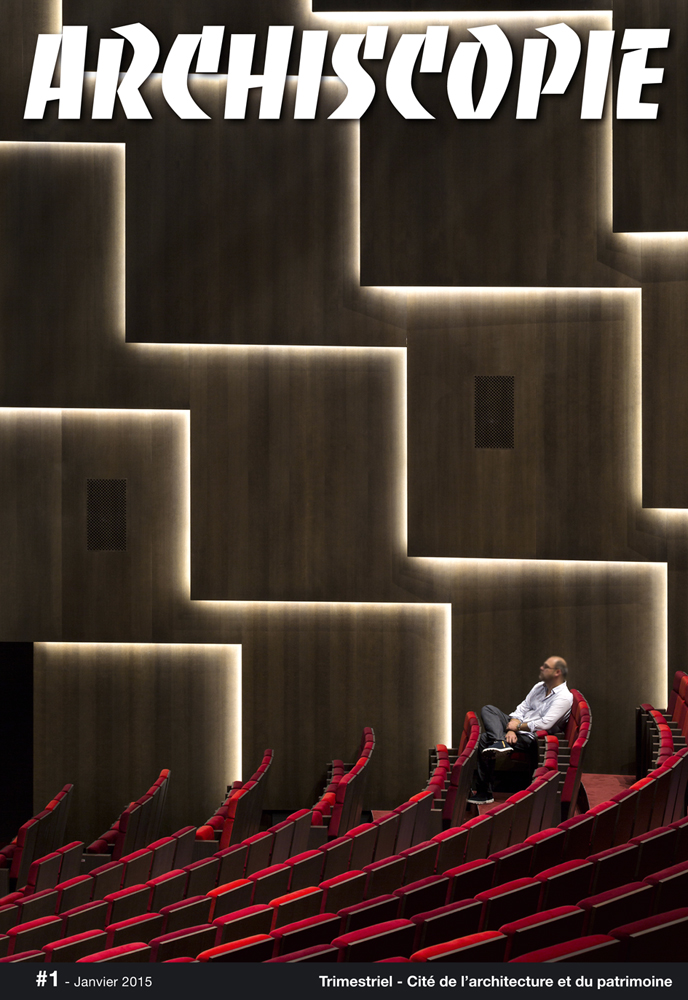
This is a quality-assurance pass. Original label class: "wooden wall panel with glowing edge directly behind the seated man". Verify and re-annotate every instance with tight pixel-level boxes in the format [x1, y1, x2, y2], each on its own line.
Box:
[412, 559, 667, 774]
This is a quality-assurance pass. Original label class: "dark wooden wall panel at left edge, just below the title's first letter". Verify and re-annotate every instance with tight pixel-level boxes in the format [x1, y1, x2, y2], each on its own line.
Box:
[0, 143, 122, 406]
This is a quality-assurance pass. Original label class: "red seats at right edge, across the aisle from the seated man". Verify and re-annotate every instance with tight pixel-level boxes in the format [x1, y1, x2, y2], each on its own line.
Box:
[636, 670, 688, 778]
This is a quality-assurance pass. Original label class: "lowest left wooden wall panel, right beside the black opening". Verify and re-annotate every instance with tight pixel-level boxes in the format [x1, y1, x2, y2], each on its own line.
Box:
[34, 643, 241, 843]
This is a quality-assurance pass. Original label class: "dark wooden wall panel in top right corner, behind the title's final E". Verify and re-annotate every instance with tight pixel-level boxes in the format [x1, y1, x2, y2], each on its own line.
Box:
[614, 0, 688, 232]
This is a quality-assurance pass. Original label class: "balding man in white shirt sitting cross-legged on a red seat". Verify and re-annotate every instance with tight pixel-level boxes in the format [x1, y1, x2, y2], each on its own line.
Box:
[467, 656, 573, 805]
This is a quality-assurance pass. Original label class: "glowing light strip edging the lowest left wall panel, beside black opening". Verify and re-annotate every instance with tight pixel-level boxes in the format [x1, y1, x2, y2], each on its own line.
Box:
[33, 642, 243, 783]
